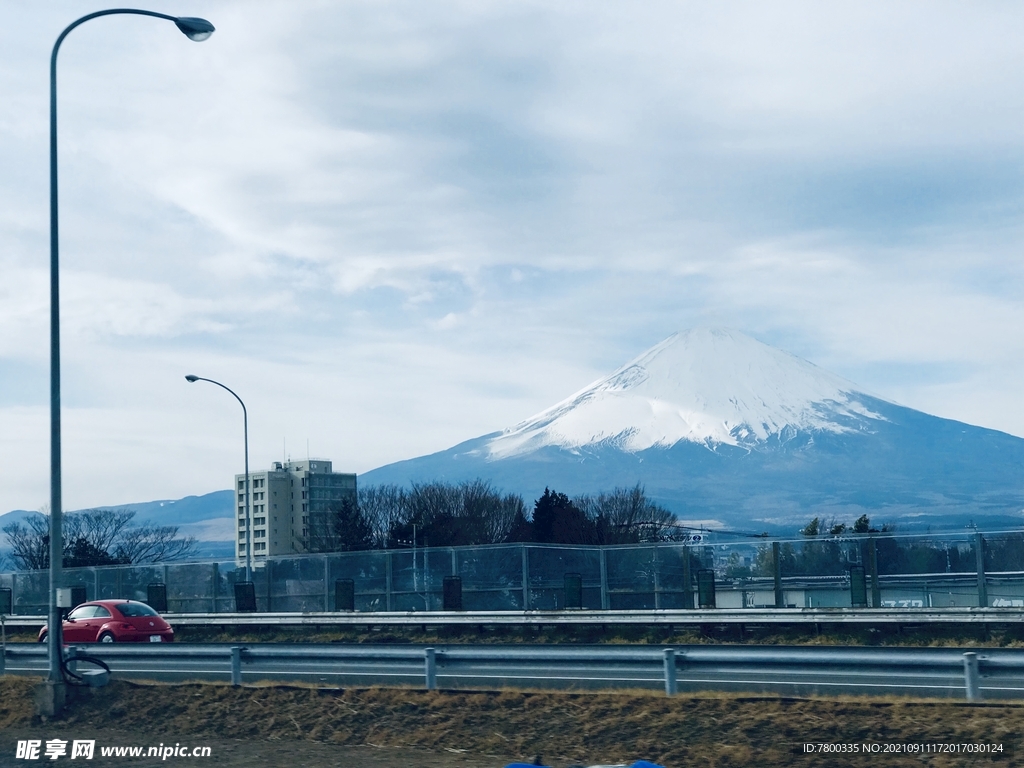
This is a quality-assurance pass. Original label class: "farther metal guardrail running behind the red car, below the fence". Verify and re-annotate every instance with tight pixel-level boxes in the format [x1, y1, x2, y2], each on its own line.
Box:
[5, 607, 1024, 630]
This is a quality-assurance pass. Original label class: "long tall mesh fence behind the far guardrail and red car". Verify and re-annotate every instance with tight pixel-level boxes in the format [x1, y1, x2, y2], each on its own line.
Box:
[0, 531, 1024, 614]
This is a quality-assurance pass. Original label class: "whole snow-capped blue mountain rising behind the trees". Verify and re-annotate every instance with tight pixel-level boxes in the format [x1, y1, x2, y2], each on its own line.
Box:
[359, 329, 1024, 531]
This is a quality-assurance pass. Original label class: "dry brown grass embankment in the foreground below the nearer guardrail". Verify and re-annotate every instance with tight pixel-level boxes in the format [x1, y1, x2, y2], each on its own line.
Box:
[0, 678, 1024, 768]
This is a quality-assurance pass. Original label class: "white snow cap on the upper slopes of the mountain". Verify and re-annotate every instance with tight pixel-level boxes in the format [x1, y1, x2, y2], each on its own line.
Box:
[481, 329, 885, 460]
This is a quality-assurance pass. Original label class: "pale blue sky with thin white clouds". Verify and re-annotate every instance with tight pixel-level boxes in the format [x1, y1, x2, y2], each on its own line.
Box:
[0, 0, 1024, 513]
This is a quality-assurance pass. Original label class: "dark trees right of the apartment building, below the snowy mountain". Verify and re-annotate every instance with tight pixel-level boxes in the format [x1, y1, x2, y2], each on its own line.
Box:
[306, 479, 678, 552]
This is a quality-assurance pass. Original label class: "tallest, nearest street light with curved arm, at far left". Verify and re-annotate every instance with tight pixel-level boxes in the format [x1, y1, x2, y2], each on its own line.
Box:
[44, 8, 214, 715]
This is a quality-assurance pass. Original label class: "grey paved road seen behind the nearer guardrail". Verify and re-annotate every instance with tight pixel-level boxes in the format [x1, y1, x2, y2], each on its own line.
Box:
[6, 643, 1024, 698]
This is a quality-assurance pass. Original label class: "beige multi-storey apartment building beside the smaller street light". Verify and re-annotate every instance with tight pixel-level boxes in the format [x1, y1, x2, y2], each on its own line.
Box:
[234, 459, 355, 564]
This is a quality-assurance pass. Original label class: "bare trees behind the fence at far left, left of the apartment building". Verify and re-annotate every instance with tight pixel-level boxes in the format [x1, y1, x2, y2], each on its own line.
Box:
[2, 509, 196, 570]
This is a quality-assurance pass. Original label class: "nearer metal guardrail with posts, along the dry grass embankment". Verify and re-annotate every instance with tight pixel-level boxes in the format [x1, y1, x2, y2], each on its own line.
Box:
[0, 643, 1011, 701]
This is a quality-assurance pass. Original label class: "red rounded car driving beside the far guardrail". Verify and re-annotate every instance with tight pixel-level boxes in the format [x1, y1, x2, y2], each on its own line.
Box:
[39, 600, 174, 643]
